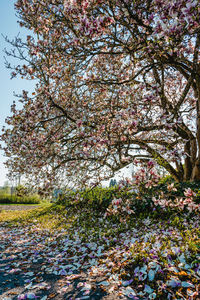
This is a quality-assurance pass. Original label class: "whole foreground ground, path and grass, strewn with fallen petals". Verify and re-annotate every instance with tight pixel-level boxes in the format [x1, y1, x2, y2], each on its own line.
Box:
[0, 207, 200, 300]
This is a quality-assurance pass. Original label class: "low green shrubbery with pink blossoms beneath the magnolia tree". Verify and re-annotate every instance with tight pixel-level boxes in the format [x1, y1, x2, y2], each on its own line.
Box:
[57, 176, 200, 218]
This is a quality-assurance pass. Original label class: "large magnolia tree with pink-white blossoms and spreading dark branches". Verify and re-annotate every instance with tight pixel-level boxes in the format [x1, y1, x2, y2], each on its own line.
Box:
[1, 0, 200, 188]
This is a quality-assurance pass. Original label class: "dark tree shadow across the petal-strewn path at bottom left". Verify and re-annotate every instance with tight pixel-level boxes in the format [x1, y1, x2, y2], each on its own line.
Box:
[0, 253, 124, 300]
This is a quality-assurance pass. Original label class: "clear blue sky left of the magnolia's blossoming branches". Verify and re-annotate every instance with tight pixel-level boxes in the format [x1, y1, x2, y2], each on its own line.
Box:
[0, 0, 33, 186]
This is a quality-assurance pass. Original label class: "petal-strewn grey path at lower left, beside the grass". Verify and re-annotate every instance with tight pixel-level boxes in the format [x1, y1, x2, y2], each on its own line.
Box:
[0, 227, 111, 299]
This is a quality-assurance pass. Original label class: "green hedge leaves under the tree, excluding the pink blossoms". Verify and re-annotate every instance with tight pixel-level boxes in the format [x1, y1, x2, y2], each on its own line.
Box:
[57, 182, 200, 214]
